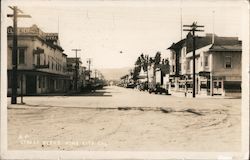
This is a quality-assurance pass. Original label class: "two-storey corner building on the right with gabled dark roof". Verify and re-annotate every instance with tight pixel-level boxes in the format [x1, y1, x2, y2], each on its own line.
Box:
[169, 34, 242, 96]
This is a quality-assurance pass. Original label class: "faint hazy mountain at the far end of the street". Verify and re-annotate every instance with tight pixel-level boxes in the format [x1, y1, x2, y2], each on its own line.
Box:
[98, 67, 132, 80]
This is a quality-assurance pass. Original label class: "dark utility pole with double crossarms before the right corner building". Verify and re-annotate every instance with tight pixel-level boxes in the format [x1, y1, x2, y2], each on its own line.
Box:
[183, 22, 204, 98]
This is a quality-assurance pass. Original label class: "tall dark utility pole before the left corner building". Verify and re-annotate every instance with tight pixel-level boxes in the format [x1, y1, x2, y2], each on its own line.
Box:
[7, 6, 31, 104]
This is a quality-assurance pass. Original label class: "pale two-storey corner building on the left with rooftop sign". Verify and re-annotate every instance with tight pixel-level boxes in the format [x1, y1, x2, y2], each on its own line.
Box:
[7, 25, 69, 95]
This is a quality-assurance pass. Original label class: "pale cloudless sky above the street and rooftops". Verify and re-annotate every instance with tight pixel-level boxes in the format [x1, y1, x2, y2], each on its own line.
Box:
[3, 0, 247, 69]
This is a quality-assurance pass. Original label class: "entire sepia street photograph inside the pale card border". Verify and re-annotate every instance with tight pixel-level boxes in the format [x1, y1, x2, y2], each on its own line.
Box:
[1, 0, 244, 158]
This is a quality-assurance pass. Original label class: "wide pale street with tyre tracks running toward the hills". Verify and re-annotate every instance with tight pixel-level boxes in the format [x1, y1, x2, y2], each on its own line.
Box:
[8, 86, 241, 151]
